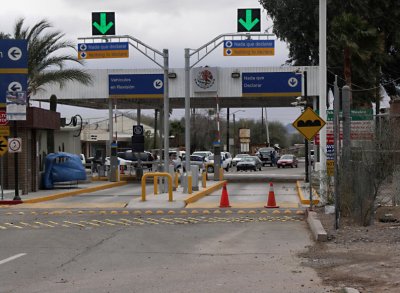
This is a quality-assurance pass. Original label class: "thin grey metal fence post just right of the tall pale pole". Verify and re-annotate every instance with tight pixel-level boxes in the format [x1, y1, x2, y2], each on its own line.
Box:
[333, 75, 340, 229]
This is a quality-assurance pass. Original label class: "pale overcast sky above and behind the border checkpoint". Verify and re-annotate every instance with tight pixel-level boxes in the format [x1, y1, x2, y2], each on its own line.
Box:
[0, 0, 299, 123]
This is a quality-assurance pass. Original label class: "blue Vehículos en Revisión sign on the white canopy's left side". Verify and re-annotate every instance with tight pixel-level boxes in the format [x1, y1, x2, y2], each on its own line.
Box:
[108, 74, 164, 99]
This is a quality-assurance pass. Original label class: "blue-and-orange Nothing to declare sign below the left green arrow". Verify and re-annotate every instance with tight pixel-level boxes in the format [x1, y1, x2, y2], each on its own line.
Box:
[78, 42, 129, 59]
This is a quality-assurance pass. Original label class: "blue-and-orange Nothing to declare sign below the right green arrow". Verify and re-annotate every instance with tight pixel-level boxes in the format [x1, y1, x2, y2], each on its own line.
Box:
[224, 40, 275, 56]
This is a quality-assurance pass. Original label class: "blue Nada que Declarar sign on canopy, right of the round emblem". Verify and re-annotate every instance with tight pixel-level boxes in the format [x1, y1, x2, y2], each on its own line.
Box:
[242, 72, 301, 97]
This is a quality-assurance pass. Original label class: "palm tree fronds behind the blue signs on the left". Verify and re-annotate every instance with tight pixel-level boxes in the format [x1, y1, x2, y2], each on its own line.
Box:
[0, 18, 92, 98]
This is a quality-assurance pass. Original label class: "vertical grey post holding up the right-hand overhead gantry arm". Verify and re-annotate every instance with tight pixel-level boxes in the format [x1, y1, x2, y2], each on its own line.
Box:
[185, 48, 190, 172]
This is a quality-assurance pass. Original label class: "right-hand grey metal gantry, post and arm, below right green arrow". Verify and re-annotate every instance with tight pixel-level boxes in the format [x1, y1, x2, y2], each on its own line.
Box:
[185, 33, 274, 170]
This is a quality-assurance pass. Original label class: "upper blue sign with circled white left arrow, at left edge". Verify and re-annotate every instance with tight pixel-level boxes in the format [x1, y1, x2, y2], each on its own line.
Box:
[0, 40, 28, 74]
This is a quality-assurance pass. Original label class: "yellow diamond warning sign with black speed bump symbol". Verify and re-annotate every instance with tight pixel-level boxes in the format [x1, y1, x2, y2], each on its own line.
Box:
[292, 108, 326, 140]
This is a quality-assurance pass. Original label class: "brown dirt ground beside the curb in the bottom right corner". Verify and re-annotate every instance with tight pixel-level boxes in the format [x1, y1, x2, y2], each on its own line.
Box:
[301, 207, 400, 293]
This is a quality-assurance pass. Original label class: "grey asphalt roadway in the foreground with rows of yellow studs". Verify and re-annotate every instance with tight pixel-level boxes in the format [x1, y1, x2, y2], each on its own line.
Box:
[0, 210, 333, 293]
